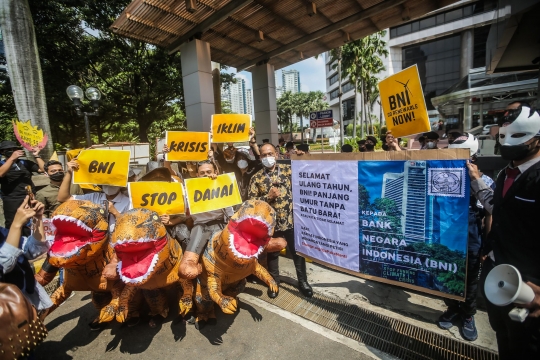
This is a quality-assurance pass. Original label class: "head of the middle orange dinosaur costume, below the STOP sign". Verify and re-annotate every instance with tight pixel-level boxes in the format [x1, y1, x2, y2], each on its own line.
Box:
[111, 209, 170, 285]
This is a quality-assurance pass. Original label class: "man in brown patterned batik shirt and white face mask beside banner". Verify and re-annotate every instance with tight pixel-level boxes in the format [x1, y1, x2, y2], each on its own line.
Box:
[249, 144, 313, 299]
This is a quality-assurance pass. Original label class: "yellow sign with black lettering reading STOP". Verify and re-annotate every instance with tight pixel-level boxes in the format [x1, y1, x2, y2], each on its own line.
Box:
[128, 181, 185, 215]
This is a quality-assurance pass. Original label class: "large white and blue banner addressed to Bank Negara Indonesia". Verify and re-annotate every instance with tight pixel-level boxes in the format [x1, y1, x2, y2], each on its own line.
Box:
[292, 150, 475, 299]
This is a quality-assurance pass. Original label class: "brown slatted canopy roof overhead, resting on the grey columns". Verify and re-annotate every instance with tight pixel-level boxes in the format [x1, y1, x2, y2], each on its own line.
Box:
[111, 0, 457, 71]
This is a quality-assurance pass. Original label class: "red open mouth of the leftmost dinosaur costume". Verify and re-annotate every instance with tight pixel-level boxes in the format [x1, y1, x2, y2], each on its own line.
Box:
[49, 215, 107, 257]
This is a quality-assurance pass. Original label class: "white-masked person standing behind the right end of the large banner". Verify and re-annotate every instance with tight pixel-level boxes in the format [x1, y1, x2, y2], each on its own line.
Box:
[437, 133, 493, 341]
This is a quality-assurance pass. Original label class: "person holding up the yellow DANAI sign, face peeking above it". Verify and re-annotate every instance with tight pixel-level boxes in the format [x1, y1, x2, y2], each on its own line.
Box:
[179, 160, 234, 279]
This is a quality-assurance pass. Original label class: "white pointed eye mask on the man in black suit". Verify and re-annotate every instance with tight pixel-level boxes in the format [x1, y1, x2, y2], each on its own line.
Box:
[499, 106, 540, 146]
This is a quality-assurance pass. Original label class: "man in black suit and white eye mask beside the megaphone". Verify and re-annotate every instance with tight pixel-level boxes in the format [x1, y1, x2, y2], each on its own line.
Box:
[473, 102, 540, 360]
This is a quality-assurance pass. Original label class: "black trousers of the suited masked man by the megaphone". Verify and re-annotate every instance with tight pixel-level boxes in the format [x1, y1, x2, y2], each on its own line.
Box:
[480, 258, 540, 360]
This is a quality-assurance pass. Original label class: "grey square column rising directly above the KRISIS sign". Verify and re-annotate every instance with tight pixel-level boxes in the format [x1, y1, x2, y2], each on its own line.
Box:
[180, 39, 214, 131]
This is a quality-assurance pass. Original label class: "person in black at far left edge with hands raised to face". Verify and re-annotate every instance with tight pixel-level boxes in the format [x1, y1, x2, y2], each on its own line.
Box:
[0, 140, 45, 232]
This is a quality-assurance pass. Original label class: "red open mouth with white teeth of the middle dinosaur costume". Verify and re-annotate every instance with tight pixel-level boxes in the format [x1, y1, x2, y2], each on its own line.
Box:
[112, 236, 167, 284]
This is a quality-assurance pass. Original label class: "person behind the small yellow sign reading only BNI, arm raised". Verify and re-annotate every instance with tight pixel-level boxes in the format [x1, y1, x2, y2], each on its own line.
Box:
[58, 160, 130, 232]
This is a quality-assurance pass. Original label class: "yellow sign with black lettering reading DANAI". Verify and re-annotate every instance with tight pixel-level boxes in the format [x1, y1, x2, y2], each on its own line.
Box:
[185, 173, 242, 214]
